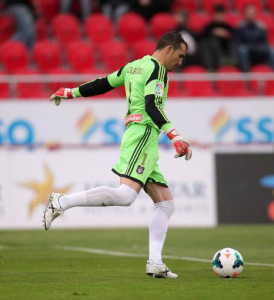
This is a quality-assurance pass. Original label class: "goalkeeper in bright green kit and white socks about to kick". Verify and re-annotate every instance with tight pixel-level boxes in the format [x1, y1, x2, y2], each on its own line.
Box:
[43, 31, 192, 278]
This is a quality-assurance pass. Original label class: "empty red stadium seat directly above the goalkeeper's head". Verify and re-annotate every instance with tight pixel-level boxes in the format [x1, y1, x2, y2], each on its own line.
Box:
[150, 13, 177, 39]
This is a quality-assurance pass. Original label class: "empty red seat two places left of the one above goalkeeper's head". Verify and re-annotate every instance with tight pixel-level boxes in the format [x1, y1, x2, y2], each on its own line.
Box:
[85, 13, 113, 44]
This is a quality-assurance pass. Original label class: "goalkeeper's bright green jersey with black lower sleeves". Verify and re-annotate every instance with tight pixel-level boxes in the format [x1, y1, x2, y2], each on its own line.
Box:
[76, 55, 171, 132]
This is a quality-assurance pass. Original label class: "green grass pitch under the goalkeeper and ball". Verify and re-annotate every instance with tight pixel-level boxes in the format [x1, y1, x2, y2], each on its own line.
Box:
[0, 224, 274, 300]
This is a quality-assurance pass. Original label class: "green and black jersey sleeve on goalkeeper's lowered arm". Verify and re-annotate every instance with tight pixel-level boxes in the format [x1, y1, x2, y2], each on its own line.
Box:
[144, 59, 170, 129]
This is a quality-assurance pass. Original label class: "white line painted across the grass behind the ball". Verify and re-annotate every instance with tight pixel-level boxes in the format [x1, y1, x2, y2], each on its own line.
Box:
[56, 246, 274, 268]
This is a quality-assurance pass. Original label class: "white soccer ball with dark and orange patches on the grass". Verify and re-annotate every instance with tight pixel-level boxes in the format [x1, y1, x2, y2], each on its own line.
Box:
[212, 248, 244, 278]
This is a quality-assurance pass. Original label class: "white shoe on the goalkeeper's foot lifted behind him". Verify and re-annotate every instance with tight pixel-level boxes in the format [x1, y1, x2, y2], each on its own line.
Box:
[43, 193, 64, 230]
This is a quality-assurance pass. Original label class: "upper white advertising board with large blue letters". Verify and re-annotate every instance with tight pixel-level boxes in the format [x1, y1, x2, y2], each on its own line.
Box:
[0, 97, 274, 145]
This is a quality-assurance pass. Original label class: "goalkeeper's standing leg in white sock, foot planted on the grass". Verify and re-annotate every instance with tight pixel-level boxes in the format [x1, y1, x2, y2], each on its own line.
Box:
[146, 183, 178, 278]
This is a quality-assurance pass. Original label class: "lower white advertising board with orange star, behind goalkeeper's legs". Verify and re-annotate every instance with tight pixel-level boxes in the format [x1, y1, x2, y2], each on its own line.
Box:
[0, 146, 216, 229]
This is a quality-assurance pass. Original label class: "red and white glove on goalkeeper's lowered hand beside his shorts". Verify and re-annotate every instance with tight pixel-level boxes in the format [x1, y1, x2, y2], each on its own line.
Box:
[166, 127, 192, 160]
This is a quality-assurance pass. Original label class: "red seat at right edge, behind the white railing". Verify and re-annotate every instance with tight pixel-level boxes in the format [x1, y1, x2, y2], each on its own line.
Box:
[250, 64, 274, 95]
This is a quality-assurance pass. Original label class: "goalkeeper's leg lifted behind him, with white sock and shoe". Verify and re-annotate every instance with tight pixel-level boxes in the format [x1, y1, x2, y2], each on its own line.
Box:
[43, 177, 141, 230]
